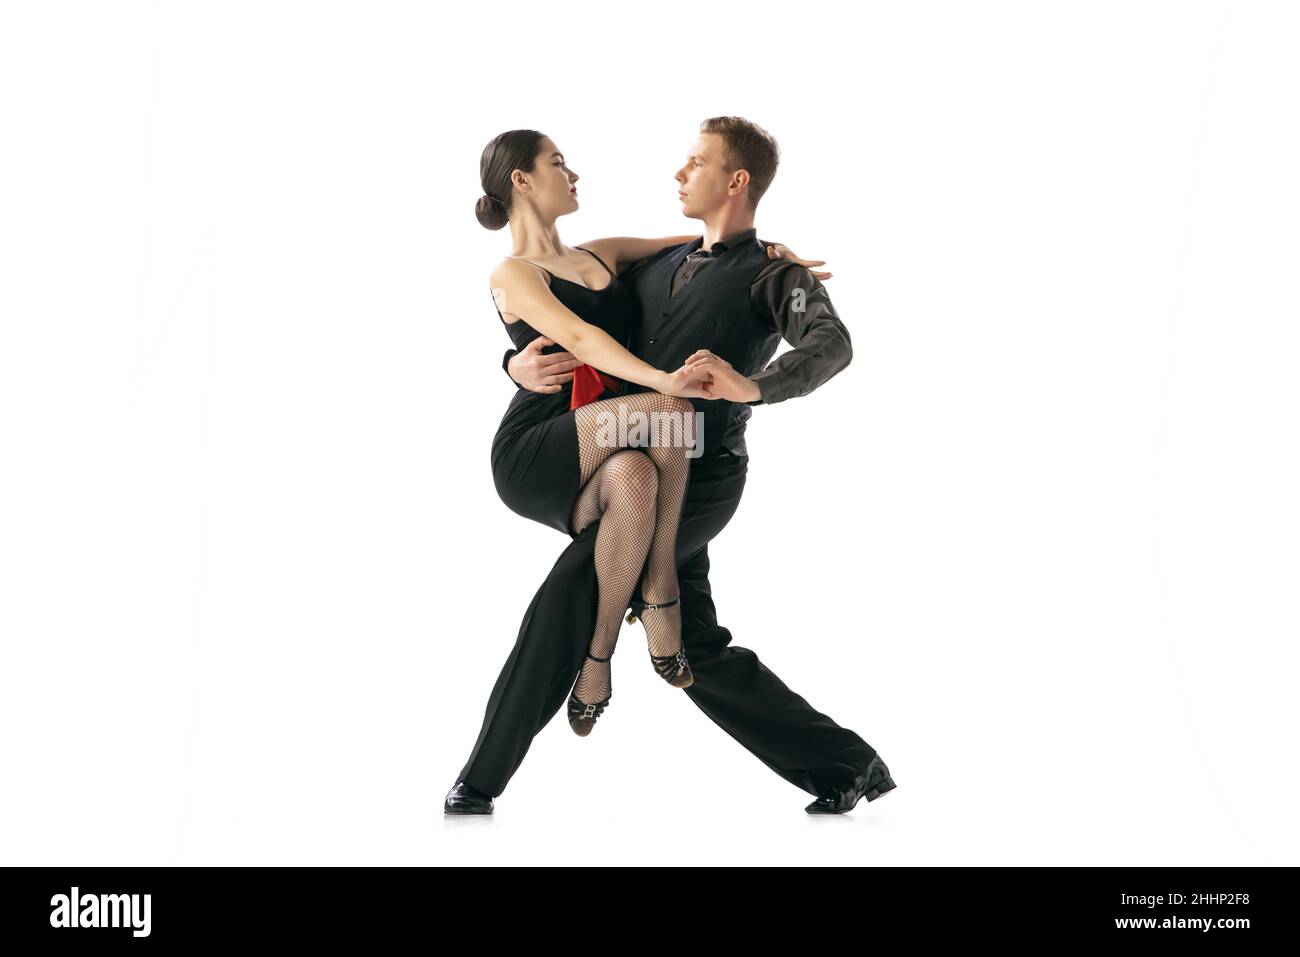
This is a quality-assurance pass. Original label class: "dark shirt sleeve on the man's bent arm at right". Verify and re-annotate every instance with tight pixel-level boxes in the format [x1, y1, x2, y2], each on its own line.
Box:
[744, 260, 853, 406]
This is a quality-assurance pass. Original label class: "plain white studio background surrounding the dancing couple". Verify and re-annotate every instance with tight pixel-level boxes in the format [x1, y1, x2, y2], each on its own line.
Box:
[0, 0, 1300, 865]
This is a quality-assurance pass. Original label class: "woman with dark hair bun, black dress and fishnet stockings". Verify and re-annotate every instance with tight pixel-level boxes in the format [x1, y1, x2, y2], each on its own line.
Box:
[476, 130, 793, 736]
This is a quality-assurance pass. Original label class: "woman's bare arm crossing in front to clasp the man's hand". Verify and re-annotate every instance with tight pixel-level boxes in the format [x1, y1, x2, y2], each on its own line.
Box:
[491, 260, 706, 398]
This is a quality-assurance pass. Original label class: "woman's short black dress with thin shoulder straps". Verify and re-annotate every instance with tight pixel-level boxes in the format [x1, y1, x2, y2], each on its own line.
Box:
[491, 246, 640, 537]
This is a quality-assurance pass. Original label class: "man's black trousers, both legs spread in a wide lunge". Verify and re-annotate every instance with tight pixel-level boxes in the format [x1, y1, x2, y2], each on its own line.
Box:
[458, 455, 875, 797]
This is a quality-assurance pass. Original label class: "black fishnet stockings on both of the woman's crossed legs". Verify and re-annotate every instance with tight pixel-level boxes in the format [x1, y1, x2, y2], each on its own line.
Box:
[573, 393, 694, 703]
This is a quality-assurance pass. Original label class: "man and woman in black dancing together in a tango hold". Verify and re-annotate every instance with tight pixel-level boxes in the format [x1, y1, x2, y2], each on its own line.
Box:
[445, 117, 894, 814]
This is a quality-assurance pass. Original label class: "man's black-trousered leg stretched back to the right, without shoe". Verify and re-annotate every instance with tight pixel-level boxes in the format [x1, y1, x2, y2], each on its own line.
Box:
[660, 458, 876, 794]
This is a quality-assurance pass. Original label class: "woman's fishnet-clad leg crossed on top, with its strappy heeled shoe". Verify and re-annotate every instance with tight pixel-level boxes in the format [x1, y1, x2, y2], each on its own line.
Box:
[573, 393, 698, 687]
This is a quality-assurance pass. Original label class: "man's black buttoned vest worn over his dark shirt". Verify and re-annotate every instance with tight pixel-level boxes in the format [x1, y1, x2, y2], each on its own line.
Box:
[627, 232, 781, 455]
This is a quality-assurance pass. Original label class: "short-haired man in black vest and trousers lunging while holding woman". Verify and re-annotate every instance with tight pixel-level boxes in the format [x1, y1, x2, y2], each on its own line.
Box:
[445, 117, 894, 814]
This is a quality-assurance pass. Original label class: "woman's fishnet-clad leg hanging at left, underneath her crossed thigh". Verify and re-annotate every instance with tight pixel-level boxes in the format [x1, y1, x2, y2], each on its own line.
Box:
[573, 449, 659, 733]
